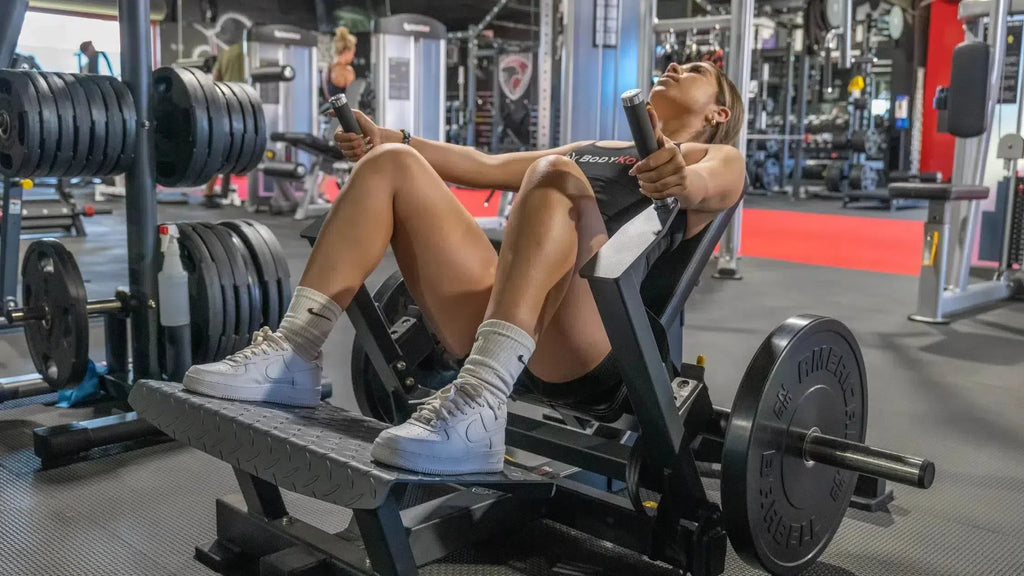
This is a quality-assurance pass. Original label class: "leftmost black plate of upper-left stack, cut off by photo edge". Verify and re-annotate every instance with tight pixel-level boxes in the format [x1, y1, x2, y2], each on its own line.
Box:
[0, 70, 43, 177]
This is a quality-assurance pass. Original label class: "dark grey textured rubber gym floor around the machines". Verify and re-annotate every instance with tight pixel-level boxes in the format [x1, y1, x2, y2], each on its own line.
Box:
[0, 190, 1024, 576]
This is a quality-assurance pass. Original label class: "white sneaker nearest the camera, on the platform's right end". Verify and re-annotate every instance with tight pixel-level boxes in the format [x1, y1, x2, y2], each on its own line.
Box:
[370, 380, 508, 475]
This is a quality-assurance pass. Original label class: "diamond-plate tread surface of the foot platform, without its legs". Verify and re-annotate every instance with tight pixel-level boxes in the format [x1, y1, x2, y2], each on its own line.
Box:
[128, 380, 555, 508]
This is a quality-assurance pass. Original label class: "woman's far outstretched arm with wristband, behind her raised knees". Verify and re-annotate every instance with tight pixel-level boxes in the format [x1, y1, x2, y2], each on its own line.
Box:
[381, 128, 581, 191]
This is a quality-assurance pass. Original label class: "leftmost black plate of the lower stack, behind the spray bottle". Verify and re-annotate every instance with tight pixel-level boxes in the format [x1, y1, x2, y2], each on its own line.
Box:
[177, 223, 224, 364]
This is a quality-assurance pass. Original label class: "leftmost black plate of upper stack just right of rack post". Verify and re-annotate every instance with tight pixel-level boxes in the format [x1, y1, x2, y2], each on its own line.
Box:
[153, 67, 210, 188]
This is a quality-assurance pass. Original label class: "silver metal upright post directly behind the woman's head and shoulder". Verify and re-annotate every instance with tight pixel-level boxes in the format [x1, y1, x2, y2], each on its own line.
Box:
[715, 0, 754, 280]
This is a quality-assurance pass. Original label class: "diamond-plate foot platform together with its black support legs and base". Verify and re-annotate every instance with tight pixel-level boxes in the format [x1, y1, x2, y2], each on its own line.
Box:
[128, 380, 555, 576]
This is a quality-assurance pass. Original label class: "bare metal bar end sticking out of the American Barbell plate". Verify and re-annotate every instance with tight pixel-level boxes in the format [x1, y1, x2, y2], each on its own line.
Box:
[804, 430, 935, 489]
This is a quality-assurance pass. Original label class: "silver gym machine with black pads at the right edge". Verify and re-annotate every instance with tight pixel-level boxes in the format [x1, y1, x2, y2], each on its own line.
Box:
[889, 0, 1024, 324]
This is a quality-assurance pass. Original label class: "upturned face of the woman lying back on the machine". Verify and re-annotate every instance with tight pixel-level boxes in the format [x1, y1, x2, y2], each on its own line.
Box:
[650, 61, 721, 119]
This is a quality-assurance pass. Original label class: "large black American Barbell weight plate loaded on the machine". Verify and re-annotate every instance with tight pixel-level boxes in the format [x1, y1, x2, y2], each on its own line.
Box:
[722, 315, 867, 575]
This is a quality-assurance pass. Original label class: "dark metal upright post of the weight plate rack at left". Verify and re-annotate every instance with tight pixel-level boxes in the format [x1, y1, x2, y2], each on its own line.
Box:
[118, 0, 160, 379]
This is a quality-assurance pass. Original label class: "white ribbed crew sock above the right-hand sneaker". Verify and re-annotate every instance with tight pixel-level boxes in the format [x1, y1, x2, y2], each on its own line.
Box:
[456, 320, 537, 399]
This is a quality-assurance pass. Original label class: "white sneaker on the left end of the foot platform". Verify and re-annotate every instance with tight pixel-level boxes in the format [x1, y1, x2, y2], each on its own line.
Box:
[182, 327, 322, 406]
